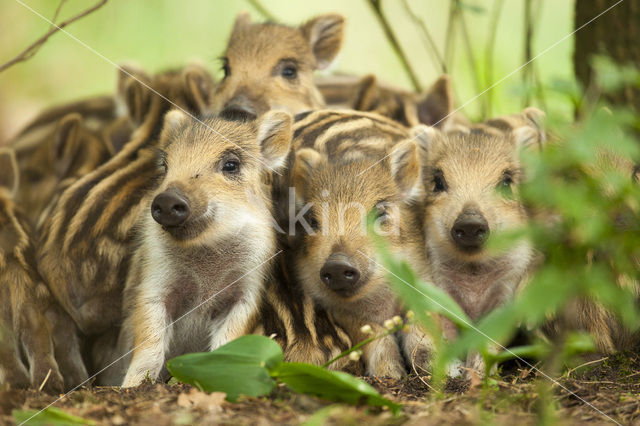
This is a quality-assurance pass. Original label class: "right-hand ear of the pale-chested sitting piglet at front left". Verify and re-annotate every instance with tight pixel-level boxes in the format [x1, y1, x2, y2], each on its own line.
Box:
[258, 111, 293, 172]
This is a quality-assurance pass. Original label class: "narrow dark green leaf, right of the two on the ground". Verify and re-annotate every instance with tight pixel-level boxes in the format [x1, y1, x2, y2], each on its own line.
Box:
[270, 362, 402, 414]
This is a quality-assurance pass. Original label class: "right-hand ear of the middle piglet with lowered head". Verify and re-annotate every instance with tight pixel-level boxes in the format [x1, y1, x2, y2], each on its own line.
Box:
[389, 139, 422, 202]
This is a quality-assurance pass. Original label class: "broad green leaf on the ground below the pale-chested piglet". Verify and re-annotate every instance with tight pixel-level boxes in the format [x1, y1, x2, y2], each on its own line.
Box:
[167, 335, 284, 401]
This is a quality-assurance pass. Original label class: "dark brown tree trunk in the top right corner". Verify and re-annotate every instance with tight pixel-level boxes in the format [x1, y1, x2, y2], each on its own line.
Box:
[573, 0, 640, 113]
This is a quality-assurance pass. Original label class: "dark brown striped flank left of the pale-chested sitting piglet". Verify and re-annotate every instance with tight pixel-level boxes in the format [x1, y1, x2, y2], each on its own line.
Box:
[37, 65, 210, 346]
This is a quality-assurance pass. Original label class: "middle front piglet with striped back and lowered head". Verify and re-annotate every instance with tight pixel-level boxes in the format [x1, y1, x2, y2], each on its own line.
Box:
[289, 111, 432, 377]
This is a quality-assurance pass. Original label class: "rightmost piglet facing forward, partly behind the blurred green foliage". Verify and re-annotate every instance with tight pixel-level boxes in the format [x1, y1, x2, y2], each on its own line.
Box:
[423, 108, 544, 369]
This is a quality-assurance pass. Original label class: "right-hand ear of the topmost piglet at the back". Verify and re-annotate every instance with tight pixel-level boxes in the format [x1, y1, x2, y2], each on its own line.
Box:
[300, 14, 344, 69]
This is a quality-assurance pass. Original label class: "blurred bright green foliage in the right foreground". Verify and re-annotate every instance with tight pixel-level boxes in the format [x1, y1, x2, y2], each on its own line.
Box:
[381, 58, 640, 387]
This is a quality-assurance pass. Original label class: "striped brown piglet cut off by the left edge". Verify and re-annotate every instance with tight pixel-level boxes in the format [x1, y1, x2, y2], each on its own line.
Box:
[0, 149, 87, 392]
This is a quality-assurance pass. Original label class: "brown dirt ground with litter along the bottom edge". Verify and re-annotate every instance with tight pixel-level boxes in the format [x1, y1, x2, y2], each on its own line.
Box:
[0, 353, 640, 426]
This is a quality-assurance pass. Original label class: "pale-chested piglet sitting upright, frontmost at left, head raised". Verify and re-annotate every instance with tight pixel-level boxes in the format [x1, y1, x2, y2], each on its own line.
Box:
[120, 111, 291, 386]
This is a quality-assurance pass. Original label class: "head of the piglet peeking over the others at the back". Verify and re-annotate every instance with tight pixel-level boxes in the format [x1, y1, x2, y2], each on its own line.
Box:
[213, 13, 344, 118]
